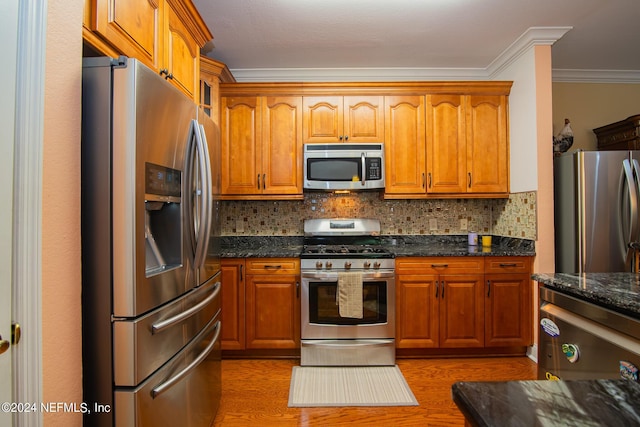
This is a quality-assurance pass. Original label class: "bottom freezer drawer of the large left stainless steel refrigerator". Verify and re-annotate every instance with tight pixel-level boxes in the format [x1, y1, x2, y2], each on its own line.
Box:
[114, 317, 221, 427]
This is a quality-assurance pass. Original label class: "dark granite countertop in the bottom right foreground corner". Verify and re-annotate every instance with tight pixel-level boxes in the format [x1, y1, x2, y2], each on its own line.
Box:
[451, 380, 640, 427]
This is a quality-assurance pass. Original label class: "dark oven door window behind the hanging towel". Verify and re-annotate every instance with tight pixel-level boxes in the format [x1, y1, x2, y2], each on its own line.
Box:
[309, 281, 387, 325]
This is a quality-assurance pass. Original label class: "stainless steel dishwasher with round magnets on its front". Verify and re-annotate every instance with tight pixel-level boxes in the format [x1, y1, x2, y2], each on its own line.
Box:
[538, 287, 640, 381]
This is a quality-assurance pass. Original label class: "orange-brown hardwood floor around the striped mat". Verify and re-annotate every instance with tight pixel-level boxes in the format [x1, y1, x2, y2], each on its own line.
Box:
[214, 357, 537, 427]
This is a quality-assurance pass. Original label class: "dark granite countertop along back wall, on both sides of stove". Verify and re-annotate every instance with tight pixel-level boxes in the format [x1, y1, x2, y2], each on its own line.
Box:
[222, 235, 535, 258]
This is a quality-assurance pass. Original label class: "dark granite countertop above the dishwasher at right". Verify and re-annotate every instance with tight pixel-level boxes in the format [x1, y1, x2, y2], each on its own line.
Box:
[531, 273, 640, 318]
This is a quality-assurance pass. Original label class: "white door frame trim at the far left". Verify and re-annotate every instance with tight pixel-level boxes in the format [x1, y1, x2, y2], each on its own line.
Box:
[12, 0, 47, 427]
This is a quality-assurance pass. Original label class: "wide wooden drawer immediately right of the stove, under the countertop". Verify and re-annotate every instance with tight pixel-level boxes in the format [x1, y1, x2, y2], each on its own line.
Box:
[396, 257, 484, 274]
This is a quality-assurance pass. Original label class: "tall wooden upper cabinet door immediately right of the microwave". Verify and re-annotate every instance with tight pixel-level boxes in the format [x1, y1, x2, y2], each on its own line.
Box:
[384, 96, 426, 195]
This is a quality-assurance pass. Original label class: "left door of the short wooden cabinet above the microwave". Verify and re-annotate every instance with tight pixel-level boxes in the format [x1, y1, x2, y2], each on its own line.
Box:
[302, 96, 344, 143]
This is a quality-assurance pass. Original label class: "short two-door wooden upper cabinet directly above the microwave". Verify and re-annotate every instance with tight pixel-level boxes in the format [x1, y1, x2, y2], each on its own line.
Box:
[303, 96, 384, 143]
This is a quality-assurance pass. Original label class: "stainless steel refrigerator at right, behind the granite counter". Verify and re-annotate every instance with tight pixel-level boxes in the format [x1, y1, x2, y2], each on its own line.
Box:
[554, 151, 640, 273]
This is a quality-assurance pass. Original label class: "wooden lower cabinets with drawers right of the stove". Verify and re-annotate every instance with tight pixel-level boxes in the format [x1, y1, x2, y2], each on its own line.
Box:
[396, 257, 533, 353]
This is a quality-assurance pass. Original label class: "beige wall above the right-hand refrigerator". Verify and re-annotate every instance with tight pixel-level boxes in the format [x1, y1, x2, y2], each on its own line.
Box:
[553, 83, 640, 151]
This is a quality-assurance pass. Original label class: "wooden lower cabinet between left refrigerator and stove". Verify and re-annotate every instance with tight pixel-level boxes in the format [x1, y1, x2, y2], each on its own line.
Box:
[222, 258, 300, 355]
